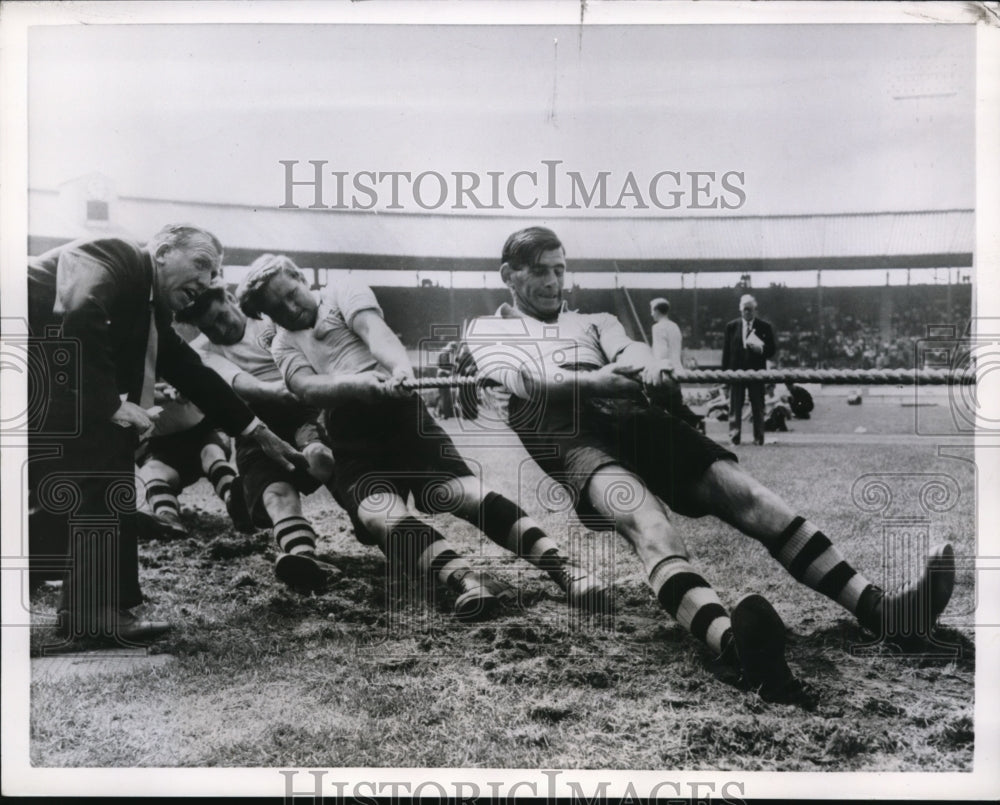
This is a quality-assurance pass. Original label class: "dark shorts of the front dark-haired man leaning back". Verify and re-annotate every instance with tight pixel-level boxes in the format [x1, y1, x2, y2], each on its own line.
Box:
[524, 399, 736, 520]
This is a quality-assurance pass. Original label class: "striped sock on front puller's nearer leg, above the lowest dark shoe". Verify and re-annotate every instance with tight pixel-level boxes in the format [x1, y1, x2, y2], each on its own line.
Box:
[649, 556, 733, 654]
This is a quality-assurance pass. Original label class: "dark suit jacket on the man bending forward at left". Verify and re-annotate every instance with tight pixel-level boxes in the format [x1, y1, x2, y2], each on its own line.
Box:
[28, 238, 253, 435]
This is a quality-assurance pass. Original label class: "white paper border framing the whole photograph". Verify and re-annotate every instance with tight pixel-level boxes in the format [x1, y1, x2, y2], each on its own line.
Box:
[0, 0, 1000, 801]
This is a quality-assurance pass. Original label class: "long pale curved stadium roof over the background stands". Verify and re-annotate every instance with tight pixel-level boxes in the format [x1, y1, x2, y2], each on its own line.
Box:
[29, 190, 974, 272]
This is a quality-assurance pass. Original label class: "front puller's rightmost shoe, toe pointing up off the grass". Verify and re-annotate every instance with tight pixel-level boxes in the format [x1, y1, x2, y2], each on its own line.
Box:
[858, 543, 955, 646]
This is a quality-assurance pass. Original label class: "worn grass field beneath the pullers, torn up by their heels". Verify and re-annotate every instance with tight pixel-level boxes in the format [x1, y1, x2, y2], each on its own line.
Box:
[31, 399, 975, 771]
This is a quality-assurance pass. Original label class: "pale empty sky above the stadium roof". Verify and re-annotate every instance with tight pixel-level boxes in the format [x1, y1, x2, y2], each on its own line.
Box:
[28, 25, 975, 215]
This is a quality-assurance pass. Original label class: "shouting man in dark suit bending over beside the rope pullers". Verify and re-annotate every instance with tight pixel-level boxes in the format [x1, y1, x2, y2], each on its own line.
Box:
[28, 225, 304, 643]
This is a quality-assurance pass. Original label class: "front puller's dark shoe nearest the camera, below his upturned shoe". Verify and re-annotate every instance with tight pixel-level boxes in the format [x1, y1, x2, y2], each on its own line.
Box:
[732, 595, 816, 710]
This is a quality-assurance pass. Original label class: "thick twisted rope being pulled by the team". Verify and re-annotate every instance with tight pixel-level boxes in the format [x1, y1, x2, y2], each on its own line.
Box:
[407, 367, 976, 391]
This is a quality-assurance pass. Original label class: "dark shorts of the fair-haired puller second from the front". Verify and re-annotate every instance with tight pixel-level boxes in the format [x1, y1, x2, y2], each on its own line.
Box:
[323, 395, 473, 538]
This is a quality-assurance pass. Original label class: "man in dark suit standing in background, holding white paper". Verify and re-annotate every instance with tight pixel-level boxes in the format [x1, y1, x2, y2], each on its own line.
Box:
[722, 294, 774, 444]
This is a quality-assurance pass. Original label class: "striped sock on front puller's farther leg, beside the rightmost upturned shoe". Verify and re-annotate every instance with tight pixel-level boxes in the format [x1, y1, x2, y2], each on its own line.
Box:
[768, 517, 872, 614]
